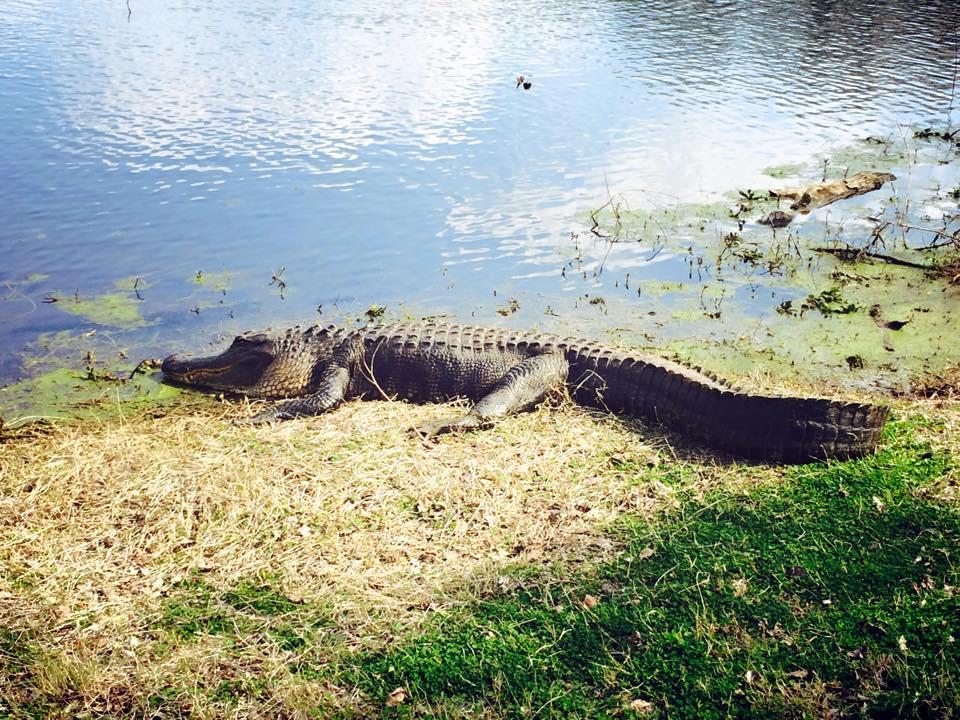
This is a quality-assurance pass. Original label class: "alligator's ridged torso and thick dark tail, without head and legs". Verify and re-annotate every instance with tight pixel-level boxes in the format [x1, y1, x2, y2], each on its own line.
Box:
[358, 322, 888, 462]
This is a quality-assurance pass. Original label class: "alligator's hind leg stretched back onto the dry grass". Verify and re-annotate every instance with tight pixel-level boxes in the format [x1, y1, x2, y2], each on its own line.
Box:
[417, 352, 568, 438]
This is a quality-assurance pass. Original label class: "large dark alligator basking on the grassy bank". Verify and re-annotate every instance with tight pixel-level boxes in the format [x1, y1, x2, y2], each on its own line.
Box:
[161, 321, 889, 463]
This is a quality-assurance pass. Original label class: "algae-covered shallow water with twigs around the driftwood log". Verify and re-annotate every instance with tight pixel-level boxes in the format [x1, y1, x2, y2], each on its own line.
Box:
[572, 128, 960, 390]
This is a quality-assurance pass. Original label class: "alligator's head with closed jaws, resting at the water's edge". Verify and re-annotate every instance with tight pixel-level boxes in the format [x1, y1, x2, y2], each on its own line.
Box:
[161, 332, 317, 398]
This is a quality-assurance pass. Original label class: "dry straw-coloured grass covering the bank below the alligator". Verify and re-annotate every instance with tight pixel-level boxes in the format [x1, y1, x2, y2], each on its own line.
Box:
[0, 390, 960, 716]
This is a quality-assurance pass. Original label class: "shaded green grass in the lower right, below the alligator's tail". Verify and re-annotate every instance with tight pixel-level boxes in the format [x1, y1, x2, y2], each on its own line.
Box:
[352, 422, 960, 718]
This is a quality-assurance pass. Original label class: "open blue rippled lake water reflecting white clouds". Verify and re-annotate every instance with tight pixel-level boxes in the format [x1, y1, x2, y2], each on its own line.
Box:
[0, 0, 960, 383]
